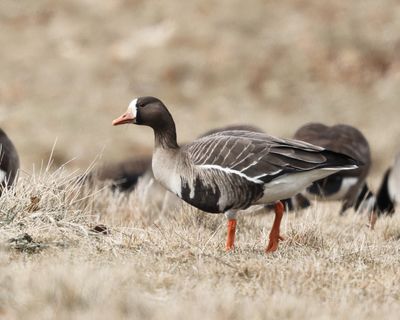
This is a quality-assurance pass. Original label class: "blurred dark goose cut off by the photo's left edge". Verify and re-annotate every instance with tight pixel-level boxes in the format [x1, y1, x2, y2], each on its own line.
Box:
[0, 129, 19, 196]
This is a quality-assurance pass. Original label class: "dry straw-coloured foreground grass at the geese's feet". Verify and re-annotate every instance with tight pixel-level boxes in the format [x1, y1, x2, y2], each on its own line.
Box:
[0, 170, 400, 319]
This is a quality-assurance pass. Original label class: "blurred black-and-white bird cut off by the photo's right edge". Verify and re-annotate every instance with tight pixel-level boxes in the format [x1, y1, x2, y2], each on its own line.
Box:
[376, 152, 400, 215]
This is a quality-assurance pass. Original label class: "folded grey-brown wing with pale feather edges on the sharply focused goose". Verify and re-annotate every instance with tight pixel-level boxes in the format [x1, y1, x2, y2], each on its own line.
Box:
[184, 130, 340, 183]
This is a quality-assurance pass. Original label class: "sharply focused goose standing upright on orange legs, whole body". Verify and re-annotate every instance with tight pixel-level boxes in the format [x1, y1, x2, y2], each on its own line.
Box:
[113, 97, 358, 252]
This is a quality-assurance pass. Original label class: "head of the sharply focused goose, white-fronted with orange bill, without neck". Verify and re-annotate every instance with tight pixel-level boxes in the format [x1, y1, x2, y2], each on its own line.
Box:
[112, 97, 172, 129]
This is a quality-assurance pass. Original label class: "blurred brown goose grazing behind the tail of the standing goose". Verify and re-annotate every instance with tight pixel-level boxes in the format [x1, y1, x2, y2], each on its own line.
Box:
[285, 123, 375, 213]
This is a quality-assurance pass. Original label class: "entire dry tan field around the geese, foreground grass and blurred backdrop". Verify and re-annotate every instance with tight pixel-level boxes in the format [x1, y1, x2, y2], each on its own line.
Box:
[0, 0, 400, 319]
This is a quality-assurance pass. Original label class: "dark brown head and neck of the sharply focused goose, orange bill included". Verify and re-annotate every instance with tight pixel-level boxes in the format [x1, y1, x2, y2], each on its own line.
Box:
[112, 97, 178, 148]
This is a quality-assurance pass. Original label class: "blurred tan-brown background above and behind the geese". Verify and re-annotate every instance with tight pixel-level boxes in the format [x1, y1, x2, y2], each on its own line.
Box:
[0, 0, 400, 188]
